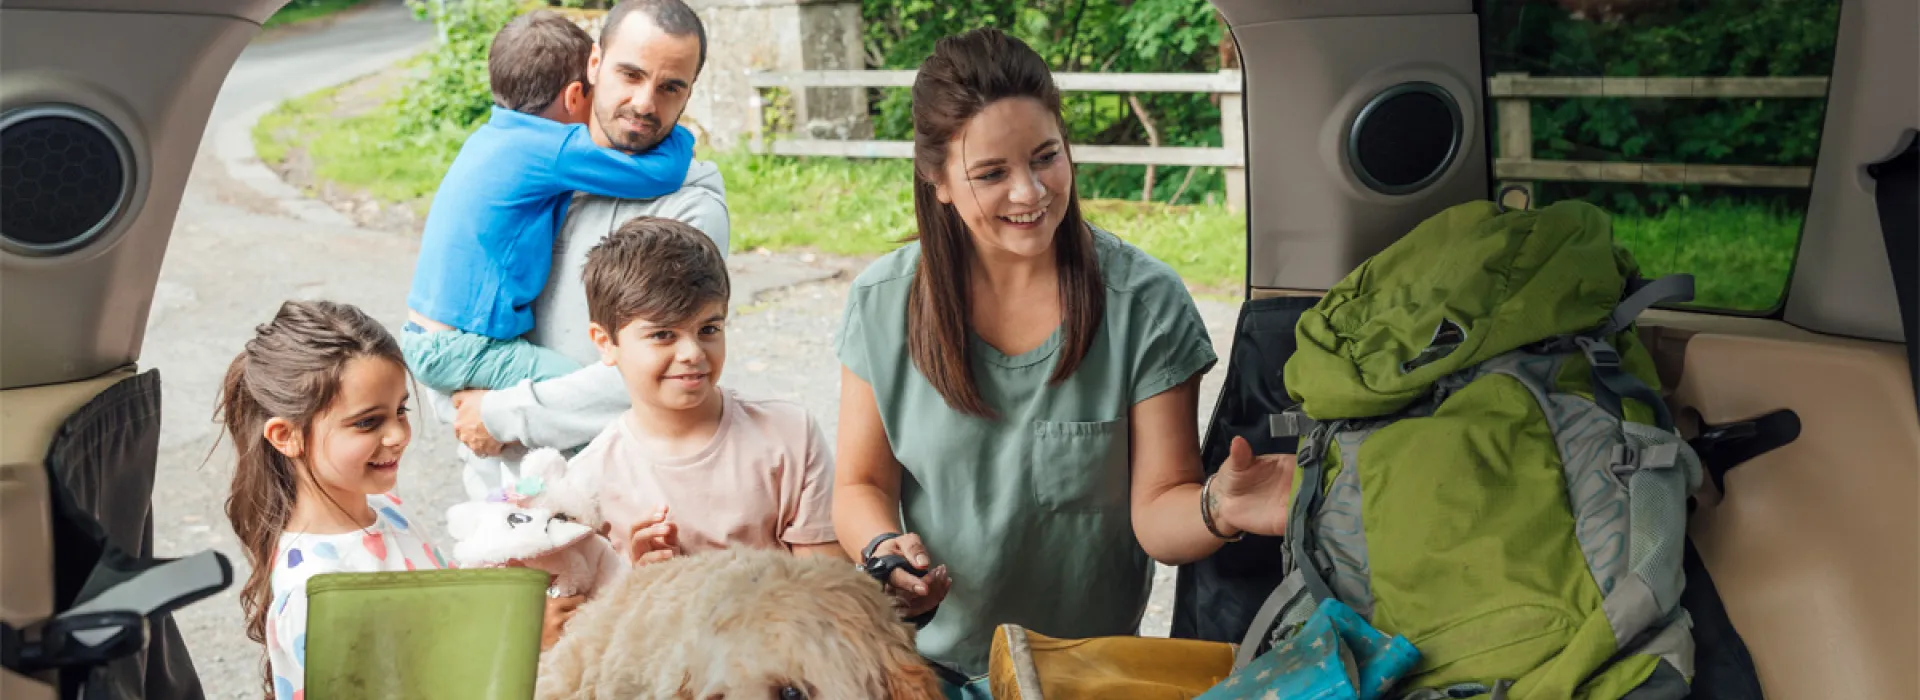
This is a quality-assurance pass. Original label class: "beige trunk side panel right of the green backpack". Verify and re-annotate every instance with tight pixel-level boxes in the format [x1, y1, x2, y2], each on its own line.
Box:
[1644, 322, 1920, 700]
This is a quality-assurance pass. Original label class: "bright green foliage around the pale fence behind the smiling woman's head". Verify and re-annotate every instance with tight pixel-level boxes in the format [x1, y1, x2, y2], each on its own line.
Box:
[862, 0, 1225, 203]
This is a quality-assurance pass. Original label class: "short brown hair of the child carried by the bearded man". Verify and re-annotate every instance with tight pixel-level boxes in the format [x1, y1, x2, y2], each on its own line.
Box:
[486, 10, 593, 115]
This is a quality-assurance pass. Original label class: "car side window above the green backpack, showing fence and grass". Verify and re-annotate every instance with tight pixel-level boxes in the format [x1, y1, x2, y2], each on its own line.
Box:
[1480, 0, 1839, 313]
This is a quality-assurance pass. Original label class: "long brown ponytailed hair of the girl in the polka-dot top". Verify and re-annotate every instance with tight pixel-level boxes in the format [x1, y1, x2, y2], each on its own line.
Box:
[217, 301, 405, 696]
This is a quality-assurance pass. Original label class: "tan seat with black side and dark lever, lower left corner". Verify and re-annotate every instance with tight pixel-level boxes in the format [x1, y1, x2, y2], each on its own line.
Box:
[0, 366, 232, 700]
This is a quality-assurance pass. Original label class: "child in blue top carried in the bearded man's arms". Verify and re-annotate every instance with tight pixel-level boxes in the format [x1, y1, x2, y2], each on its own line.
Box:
[401, 12, 693, 393]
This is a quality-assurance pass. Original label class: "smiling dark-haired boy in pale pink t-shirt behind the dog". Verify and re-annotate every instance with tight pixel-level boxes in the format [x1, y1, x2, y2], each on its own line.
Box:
[570, 217, 851, 564]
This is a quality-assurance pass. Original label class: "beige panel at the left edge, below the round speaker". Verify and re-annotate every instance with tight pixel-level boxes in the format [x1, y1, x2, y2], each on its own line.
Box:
[0, 366, 134, 700]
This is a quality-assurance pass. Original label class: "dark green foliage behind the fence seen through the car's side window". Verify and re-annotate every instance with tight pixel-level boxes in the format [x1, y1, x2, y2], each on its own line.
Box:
[1482, 0, 1839, 213]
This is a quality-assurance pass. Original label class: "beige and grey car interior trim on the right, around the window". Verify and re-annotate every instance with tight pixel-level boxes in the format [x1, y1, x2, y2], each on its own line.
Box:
[1213, 0, 1920, 700]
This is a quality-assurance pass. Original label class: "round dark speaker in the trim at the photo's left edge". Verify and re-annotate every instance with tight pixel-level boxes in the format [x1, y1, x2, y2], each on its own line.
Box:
[0, 105, 132, 255]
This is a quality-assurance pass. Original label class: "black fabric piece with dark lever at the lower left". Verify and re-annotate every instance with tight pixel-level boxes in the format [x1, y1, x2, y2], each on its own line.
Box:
[0, 370, 232, 700]
